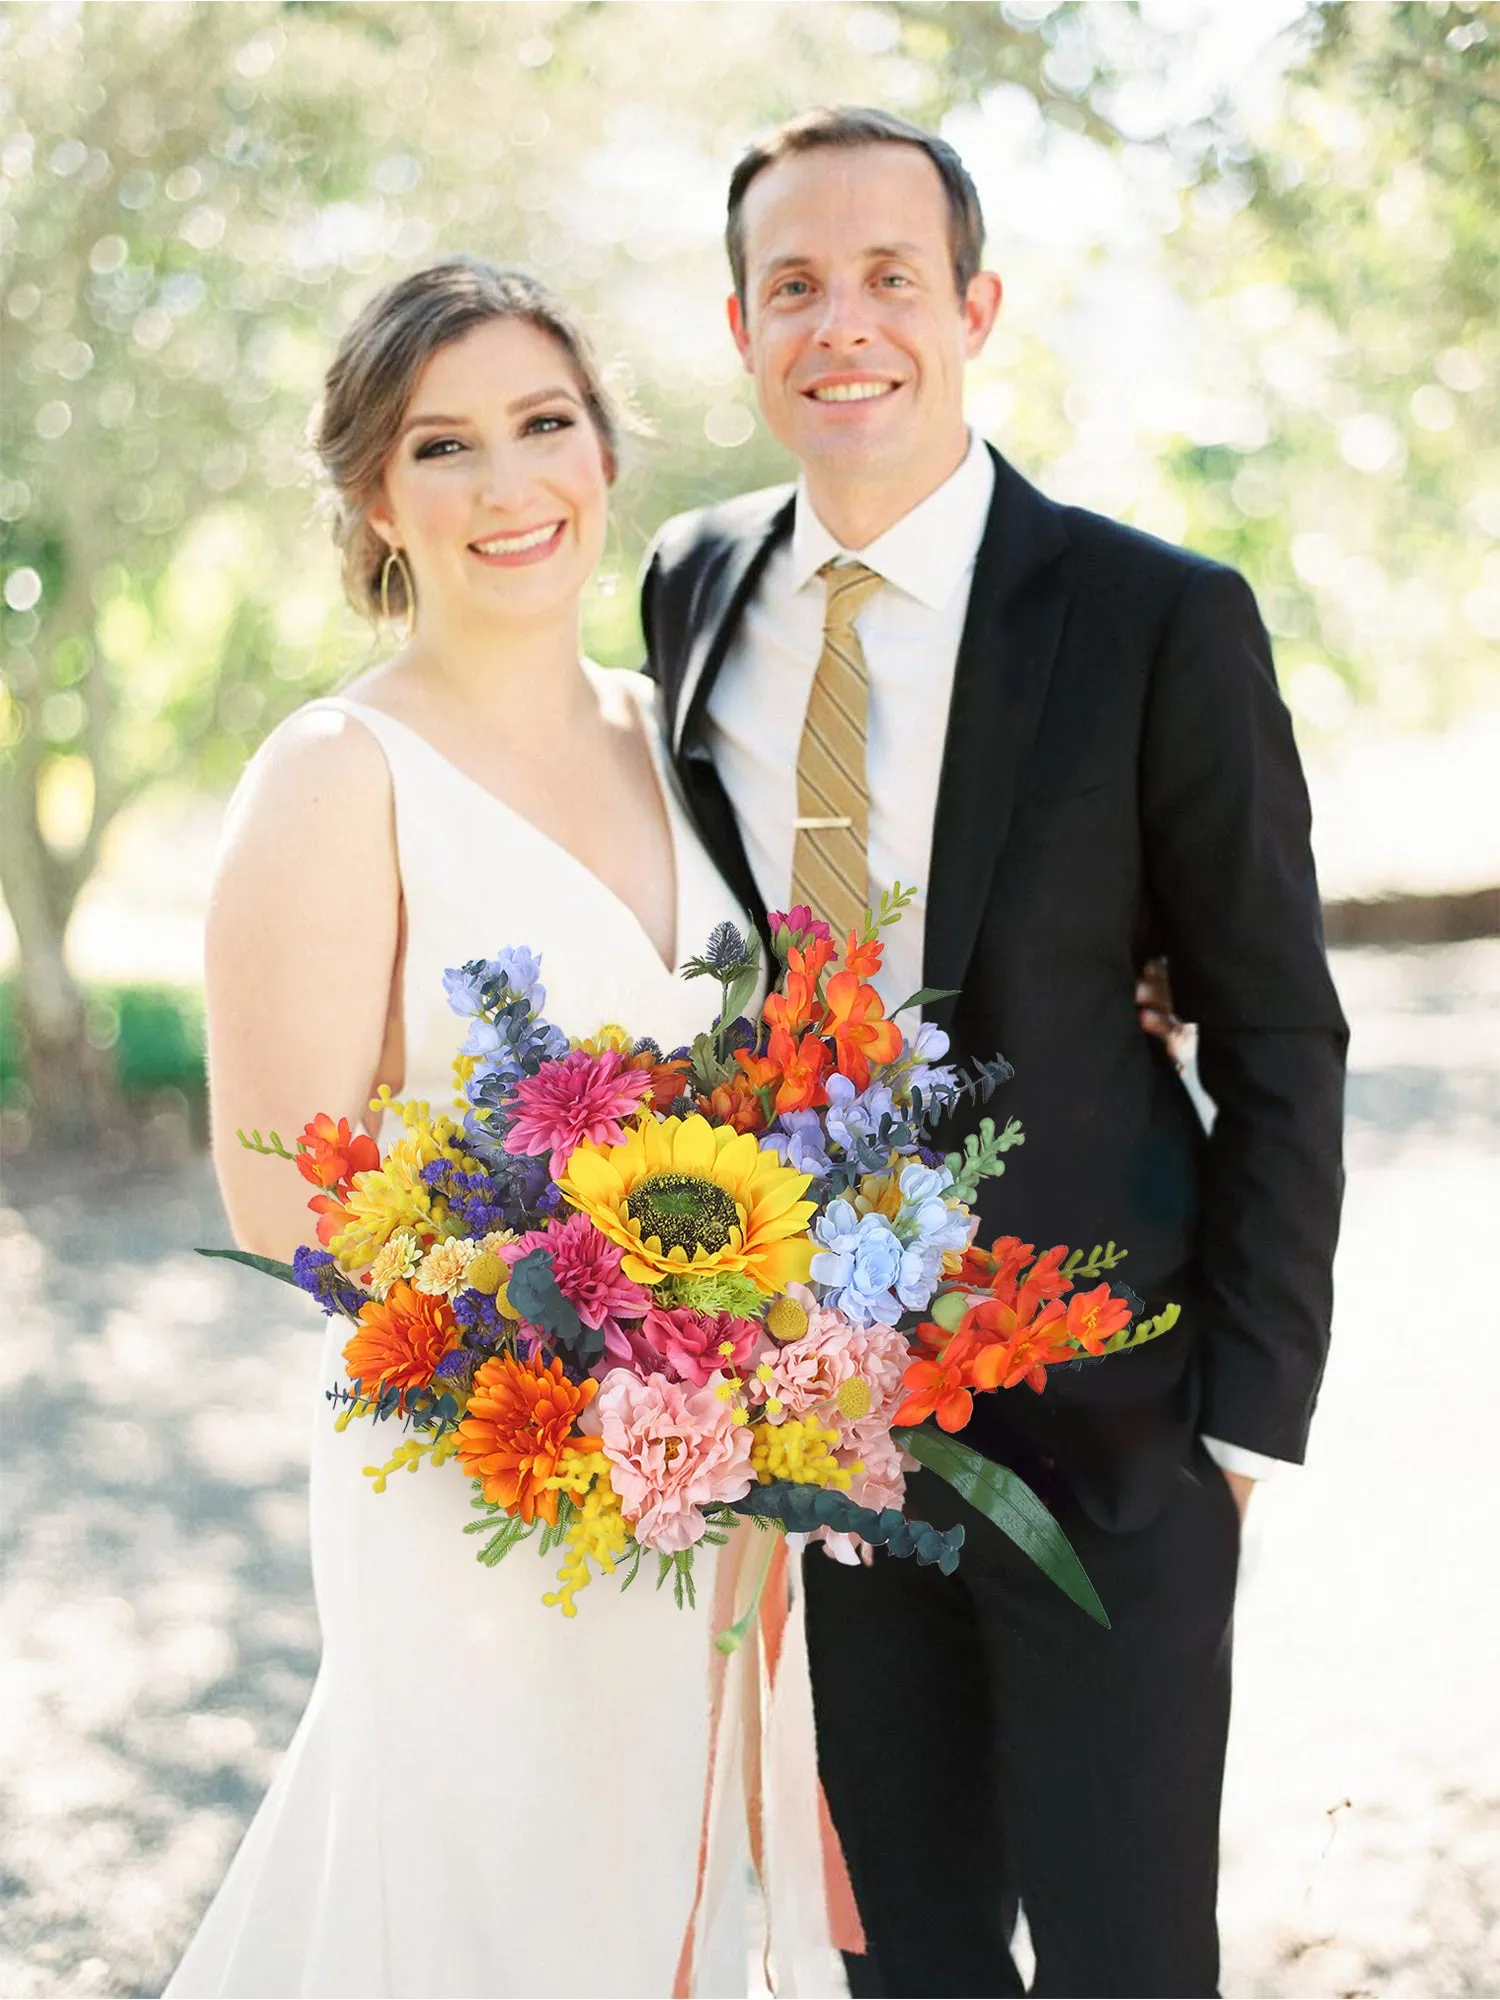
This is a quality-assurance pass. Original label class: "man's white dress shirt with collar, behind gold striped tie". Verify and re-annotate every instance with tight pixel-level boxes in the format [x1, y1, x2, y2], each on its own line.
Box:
[704, 436, 1276, 1478]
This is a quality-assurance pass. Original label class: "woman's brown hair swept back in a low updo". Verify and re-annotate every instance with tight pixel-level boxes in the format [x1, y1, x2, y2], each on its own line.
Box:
[312, 256, 620, 618]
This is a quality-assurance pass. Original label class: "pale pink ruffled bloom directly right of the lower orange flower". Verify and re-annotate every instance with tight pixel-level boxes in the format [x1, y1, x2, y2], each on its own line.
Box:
[596, 1368, 756, 1554]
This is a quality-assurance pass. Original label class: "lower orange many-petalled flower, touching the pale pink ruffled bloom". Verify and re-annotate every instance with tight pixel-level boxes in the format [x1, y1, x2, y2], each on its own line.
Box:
[458, 1354, 598, 1528]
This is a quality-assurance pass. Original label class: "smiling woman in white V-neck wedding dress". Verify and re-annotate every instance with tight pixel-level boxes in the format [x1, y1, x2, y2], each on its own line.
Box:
[168, 258, 768, 1996]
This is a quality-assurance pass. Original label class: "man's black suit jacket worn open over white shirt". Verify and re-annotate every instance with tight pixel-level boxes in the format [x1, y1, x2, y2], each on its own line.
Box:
[642, 454, 1348, 1526]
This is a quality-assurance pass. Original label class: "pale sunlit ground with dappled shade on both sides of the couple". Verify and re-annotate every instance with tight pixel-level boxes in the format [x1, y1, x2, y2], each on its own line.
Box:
[0, 942, 1500, 2000]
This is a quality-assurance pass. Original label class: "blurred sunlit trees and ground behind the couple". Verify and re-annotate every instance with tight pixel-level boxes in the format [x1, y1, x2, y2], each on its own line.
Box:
[0, 0, 1500, 1994]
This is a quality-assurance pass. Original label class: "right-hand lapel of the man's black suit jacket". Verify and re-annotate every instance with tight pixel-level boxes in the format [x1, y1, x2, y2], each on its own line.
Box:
[924, 452, 1068, 1028]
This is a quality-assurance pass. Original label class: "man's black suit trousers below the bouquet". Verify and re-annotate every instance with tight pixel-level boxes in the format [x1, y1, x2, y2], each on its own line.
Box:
[802, 1446, 1240, 2000]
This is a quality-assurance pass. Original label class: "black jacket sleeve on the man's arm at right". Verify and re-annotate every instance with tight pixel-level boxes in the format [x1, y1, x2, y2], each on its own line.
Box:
[1142, 568, 1348, 1460]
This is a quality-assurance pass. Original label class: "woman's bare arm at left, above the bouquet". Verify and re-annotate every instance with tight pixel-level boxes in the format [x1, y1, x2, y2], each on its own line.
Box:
[206, 710, 400, 1258]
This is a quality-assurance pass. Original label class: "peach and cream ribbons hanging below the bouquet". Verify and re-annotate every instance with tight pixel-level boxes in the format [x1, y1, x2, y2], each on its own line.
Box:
[672, 1522, 866, 2000]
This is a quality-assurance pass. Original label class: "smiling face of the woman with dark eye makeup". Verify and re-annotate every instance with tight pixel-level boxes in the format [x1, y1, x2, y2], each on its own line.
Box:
[370, 320, 608, 624]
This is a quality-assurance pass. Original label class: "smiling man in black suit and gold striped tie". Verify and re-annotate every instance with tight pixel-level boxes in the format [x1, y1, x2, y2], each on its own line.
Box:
[644, 110, 1346, 1996]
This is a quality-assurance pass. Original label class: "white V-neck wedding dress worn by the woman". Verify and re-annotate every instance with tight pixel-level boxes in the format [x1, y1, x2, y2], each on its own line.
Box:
[168, 668, 800, 1996]
